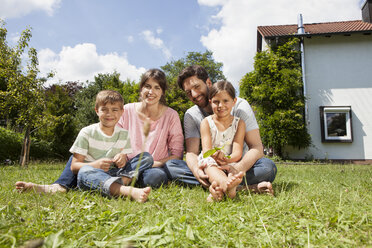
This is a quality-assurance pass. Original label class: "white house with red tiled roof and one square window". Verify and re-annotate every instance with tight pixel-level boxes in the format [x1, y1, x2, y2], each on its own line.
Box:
[257, 0, 372, 163]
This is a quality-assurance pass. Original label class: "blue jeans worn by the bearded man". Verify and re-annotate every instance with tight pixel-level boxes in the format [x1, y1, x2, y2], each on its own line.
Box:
[164, 158, 277, 185]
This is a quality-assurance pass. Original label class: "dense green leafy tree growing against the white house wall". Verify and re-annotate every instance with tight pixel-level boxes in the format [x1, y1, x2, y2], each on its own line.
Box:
[240, 38, 311, 156]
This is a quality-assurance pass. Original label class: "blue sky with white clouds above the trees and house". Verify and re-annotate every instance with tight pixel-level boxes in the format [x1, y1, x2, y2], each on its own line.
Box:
[0, 0, 364, 86]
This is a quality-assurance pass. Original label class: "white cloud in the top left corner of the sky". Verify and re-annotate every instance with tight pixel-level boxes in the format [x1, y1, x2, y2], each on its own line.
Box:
[0, 0, 61, 19]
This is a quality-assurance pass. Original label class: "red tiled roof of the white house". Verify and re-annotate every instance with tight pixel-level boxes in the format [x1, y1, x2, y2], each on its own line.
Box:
[257, 20, 372, 38]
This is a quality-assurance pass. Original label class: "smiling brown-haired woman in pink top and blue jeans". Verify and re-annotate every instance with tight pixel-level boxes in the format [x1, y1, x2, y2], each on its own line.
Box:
[16, 69, 183, 193]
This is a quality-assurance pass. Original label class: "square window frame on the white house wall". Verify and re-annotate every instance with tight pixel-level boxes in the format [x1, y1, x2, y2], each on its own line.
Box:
[319, 106, 353, 143]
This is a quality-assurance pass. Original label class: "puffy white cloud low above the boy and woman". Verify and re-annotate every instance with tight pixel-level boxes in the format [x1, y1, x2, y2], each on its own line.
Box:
[38, 43, 145, 83]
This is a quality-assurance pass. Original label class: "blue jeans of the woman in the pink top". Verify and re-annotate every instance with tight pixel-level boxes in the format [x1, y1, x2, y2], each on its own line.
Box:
[54, 153, 168, 189]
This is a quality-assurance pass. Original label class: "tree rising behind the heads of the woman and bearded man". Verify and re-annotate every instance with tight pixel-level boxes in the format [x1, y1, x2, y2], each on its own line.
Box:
[161, 50, 226, 121]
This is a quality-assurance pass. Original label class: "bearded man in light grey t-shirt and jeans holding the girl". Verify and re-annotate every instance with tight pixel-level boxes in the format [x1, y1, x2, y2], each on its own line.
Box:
[166, 65, 277, 196]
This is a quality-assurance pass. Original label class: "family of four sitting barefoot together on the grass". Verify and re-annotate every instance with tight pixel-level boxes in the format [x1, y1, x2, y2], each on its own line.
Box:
[16, 65, 277, 202]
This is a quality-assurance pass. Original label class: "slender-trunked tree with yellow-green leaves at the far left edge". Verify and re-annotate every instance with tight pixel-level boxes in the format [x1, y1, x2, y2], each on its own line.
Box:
[0, 22, 45, 166]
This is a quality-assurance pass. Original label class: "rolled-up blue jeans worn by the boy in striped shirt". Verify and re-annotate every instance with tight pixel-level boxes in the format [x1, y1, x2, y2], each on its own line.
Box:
[77, 152, 154, 196]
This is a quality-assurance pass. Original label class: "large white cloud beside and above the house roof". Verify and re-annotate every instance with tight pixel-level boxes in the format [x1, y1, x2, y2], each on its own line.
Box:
[198, 0, 361, 87]
